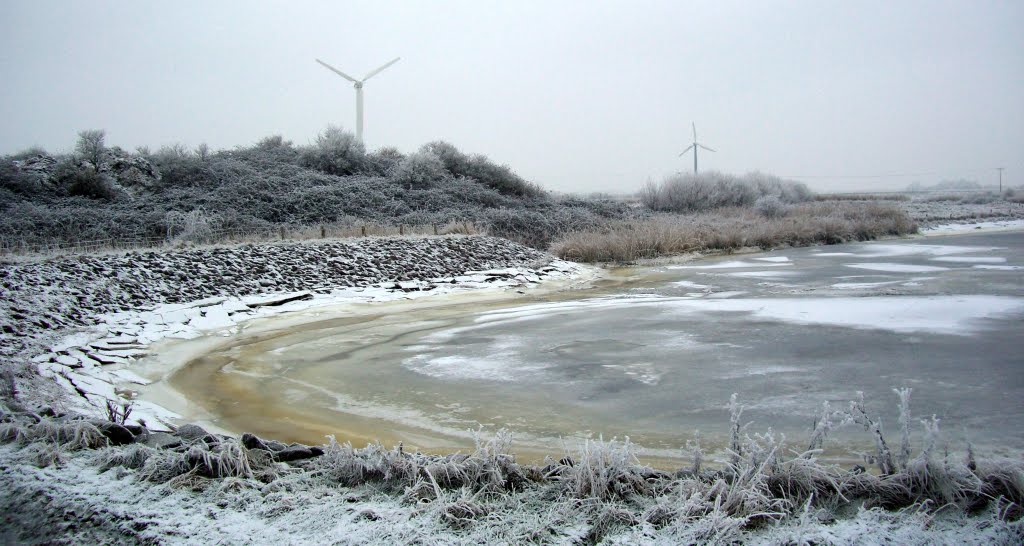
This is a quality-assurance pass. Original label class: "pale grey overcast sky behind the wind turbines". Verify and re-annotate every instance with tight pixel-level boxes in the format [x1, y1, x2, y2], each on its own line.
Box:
[0, 0, 1024, 192]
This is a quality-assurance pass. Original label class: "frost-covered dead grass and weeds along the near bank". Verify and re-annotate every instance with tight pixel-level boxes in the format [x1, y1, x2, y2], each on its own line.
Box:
[0, 389, 1024, 543]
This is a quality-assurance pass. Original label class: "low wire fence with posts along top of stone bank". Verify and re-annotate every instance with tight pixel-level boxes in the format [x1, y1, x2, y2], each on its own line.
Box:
[0, 221, 479, 256]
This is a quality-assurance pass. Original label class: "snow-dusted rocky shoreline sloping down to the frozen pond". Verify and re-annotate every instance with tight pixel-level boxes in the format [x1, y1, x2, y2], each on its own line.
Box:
[0, 236, 579, 422]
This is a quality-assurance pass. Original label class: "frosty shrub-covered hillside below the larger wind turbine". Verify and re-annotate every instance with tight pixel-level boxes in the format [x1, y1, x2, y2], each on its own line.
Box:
[0, 127, 632, 248]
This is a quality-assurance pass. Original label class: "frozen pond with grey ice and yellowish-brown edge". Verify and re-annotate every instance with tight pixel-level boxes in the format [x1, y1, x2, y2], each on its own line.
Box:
[172, 233, 1024, 465]
